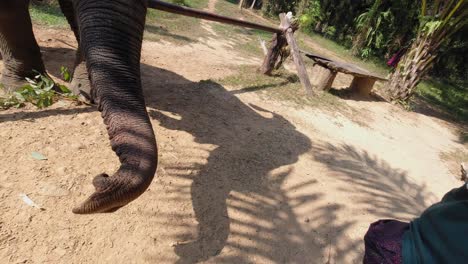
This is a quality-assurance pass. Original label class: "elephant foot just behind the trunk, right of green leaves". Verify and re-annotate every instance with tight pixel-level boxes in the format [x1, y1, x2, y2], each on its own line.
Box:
[70, 62, 95, 104]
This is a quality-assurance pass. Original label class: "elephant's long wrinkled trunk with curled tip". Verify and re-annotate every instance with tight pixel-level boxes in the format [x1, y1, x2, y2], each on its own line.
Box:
[73, 0, 157, 214]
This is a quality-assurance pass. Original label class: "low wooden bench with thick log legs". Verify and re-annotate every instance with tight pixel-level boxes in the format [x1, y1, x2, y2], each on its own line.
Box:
[304, 52, 388, 96]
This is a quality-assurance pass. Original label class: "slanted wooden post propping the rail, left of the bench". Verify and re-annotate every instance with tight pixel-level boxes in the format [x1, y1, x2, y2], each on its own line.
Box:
[280, 13, 314, 96]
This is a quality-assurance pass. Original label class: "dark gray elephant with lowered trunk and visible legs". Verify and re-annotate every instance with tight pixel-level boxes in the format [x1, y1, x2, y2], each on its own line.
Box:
[0, 0, 157, 214]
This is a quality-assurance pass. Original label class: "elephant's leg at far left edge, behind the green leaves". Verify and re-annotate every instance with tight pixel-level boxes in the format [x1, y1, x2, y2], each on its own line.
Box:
[0, 0, 46, 92]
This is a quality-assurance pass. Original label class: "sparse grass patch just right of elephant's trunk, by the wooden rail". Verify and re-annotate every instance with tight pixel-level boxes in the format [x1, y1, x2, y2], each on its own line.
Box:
[145, 0, 208, 45]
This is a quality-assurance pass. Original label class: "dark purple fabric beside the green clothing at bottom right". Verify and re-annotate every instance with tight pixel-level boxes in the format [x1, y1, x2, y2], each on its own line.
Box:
[363, 220, 409, 264]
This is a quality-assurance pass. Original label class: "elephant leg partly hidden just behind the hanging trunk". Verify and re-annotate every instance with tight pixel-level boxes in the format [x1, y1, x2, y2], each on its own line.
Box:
[59, 0, 94, 104]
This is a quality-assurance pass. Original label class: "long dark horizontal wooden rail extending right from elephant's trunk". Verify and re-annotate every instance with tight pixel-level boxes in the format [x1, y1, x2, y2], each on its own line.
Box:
[148, 0, 283, 34]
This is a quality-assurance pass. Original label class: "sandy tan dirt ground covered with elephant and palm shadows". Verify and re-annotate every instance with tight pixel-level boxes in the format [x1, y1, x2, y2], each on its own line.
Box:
[0, 13, 464, 263]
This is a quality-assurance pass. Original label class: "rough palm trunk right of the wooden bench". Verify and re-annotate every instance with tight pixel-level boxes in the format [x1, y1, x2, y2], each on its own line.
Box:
[388, 36, 439, 102]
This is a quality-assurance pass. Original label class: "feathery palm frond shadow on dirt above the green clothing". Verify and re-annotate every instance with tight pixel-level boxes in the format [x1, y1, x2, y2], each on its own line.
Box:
[313, 144, 436, 221]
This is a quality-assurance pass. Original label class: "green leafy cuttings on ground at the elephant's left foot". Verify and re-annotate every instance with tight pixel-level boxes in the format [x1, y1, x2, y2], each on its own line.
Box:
[0, 73, 77, 109]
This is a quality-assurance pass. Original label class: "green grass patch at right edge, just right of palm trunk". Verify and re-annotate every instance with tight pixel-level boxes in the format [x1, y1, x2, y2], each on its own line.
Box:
[416, 80, 468, 122]
